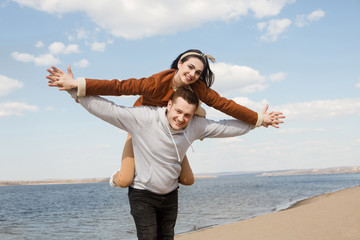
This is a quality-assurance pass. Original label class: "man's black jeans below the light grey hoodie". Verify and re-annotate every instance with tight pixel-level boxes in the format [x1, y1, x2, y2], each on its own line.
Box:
[128, 187, 178, 240]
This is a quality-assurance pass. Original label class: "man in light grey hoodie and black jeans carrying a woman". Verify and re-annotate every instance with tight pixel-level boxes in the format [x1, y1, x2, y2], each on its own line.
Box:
[69, 88, 254, 240]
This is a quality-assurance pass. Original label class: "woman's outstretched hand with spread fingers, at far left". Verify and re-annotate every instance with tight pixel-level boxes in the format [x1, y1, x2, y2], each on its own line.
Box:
[46, 66, 78, 91]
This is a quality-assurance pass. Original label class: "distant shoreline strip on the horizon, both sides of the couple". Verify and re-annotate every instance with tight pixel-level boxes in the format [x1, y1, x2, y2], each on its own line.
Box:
[0, 167, 360, 186]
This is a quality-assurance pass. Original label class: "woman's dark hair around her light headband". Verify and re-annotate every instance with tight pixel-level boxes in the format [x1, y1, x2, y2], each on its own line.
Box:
[170, 49, 215, 87]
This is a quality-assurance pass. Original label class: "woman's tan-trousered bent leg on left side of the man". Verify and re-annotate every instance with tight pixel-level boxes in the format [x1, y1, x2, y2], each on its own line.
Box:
[113, 134, 135, 188]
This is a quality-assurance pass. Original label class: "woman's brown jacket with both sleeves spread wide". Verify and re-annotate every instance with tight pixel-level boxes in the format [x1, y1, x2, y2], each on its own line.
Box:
[81, 69, 262, 126]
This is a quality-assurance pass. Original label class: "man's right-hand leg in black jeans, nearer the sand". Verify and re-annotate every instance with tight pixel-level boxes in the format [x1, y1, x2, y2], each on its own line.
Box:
[157, 189, 178, 240]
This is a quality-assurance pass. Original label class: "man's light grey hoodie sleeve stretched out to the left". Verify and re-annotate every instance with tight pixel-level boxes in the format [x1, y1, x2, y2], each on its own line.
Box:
[68, 89, 142, 133]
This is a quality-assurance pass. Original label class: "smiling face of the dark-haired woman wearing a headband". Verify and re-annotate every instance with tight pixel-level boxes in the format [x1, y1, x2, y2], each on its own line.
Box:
[177, 57, 204, 85]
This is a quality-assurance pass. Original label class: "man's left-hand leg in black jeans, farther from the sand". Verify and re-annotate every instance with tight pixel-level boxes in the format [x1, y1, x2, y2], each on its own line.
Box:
[129, 187, 158, 240]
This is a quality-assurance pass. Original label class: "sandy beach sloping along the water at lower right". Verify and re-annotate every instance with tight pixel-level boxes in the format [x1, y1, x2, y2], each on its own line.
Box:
[175, 186, 360, 240]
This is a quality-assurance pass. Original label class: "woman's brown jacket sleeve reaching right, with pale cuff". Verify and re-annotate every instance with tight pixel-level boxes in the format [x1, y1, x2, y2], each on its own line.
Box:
[192, 81, 263, 127]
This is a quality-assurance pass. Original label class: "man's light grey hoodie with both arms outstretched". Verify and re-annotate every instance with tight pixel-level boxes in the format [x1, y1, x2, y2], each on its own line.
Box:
[69, 90, 254, 194]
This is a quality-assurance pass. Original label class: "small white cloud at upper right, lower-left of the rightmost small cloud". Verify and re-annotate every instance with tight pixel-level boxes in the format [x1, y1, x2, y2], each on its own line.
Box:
[257, 18, 292, 42]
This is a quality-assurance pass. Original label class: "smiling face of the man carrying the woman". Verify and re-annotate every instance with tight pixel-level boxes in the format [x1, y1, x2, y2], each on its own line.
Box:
[166, 97, 196, 130]
